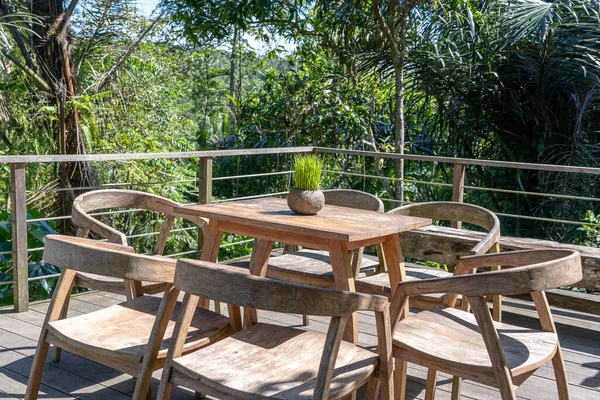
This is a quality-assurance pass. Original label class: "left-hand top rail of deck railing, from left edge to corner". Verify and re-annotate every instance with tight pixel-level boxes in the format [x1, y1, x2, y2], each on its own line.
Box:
[0, 146, 314, 164]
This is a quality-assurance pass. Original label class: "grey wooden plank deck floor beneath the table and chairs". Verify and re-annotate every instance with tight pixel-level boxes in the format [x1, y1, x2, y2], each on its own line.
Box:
[0, 292, 600, 400]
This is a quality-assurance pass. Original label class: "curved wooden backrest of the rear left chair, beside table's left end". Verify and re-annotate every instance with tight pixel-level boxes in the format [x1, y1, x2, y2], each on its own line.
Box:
[72, 189, 206, 254]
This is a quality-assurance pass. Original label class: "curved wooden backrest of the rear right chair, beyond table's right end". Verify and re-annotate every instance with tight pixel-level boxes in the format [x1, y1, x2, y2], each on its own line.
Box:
[388, 201, 500, 264]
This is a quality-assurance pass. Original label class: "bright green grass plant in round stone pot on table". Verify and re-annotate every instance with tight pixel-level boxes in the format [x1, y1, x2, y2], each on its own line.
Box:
[288, 155, 325, 215]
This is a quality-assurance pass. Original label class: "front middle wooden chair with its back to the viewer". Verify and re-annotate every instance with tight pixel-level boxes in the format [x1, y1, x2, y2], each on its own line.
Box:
[157, 260, 393, 399]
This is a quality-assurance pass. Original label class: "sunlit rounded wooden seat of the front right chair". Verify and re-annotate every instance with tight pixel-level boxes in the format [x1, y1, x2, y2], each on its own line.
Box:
[393, 307, 558, 384]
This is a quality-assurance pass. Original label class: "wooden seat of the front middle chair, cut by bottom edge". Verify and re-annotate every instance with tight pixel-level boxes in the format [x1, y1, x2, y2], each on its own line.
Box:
[171, 323, 378, 399]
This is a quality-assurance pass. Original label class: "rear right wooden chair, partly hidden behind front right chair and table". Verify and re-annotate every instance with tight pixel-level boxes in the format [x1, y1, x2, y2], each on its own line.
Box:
[356, 201, 501, 321]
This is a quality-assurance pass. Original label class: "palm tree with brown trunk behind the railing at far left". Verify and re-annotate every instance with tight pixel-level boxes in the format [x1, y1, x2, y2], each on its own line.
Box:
[0, 0, 162, 225]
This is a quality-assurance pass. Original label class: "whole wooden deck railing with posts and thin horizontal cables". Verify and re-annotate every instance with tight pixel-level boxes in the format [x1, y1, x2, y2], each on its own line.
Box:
[0, 146, 600, 312]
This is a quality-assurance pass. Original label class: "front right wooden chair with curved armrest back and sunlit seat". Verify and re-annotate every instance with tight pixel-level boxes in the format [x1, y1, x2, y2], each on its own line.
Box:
[391, 250, 582, 400]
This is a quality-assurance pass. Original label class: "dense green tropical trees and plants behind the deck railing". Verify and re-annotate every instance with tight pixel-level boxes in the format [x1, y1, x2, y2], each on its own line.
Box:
[0, 0, 600, 304]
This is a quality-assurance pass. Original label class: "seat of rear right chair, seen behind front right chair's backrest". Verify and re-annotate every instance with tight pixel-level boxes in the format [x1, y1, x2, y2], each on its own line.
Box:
[356, 263, 461, 310]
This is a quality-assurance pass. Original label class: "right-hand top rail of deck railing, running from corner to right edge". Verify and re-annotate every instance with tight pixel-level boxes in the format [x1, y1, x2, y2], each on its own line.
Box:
[315, 147, 600, 175]
